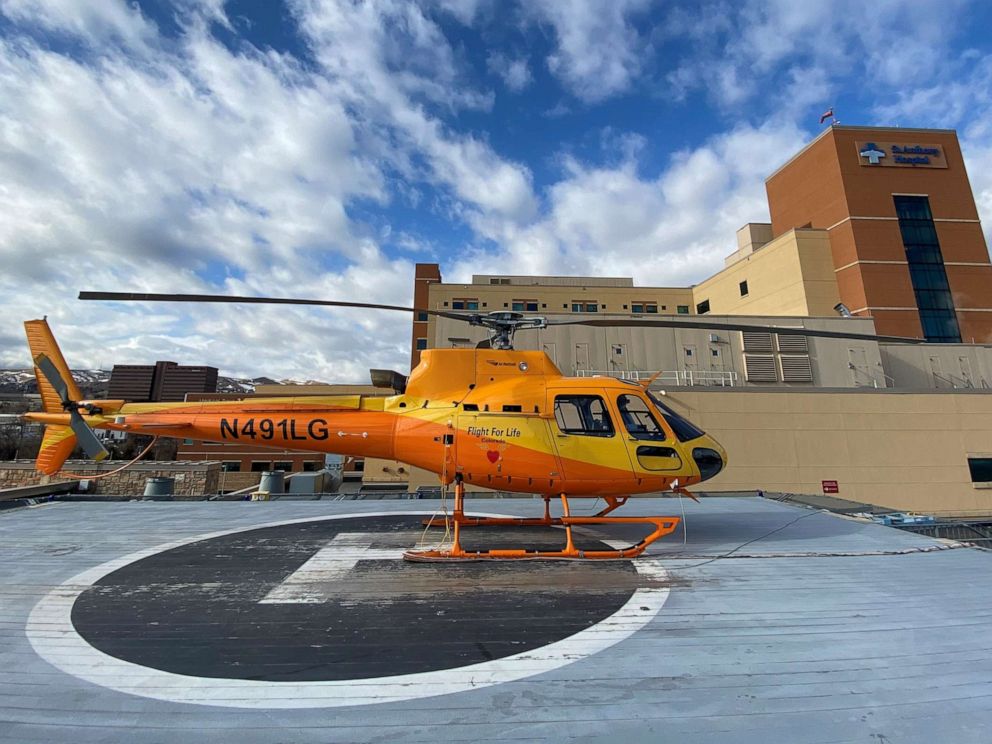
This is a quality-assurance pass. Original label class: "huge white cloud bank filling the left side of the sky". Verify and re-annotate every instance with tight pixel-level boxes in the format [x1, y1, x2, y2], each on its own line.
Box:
[0, 0, 535, 380]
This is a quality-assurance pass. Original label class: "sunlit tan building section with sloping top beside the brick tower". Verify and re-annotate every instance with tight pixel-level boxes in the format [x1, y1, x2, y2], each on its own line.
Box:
[692, 229, 840, 316]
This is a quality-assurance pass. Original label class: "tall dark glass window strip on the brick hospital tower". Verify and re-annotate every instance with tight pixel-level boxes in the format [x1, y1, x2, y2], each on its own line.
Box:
[893, 196, 961, 343]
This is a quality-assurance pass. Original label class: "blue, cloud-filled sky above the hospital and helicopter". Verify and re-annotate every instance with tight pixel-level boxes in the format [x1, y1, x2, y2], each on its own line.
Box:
[0, 0, 992, 382]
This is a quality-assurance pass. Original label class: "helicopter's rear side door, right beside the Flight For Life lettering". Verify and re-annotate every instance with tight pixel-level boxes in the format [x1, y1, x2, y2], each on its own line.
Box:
[549, 390, 634, 492]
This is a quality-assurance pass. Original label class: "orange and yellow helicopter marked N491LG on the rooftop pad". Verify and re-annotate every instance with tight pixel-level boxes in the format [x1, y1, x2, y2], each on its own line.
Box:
[24, 292, 923, 562]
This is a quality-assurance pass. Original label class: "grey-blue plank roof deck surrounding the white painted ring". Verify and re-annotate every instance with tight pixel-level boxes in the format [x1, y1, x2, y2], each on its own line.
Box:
[0, 498, 992, 744]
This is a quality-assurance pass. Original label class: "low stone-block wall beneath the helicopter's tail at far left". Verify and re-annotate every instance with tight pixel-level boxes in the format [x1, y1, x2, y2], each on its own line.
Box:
[0, 460, 221, 499]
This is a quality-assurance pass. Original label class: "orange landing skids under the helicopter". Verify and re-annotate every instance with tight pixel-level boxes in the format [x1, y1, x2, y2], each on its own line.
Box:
[403, 481, 681, 563]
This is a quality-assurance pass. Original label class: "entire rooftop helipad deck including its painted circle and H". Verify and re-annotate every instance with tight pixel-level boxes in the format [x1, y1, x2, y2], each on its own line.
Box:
[0, 498, 992, 743]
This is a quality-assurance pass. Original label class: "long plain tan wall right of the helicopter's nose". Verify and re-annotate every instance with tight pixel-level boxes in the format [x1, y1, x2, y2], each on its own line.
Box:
[666, 390, 992, 516]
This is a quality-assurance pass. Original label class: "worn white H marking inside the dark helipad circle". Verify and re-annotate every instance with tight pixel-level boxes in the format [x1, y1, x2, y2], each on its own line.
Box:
[259, 532, 403, 604]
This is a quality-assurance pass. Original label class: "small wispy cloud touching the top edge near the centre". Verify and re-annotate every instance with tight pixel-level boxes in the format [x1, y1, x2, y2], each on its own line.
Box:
[524, 0, 650, 103]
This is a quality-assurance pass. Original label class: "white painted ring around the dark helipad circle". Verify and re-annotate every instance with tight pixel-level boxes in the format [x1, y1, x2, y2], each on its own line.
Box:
[25, 511, 669, 709]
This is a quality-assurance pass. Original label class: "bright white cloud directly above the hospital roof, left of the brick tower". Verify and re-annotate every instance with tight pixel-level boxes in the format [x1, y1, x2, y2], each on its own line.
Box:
[454, 122, 807, 286]
